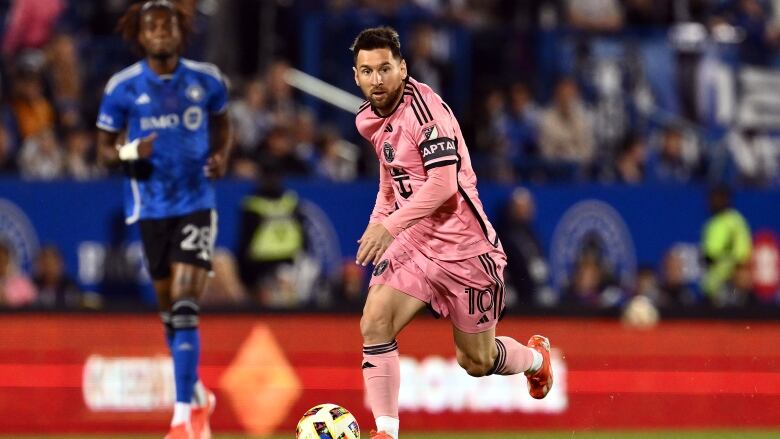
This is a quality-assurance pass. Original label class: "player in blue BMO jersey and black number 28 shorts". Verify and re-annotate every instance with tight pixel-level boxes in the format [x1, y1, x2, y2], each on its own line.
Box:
[97, 0, 232, 439]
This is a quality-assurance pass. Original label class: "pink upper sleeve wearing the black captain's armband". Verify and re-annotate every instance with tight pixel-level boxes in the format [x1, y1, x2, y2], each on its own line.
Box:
[414, 96, 460, 171]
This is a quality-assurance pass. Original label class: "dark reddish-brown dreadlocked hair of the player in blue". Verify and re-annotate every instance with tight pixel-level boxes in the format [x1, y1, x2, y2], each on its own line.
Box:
[116, 0, 192, 55]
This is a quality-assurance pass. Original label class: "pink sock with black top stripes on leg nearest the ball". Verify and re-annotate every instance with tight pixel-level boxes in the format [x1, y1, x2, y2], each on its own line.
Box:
[363, 340, 401, 419]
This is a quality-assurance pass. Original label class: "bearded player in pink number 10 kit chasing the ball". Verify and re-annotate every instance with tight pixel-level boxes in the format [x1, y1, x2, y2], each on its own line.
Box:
[351, 27, 553, 439]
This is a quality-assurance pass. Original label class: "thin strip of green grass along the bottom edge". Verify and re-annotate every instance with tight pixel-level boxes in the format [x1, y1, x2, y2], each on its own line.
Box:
[9, 430, 780, 439]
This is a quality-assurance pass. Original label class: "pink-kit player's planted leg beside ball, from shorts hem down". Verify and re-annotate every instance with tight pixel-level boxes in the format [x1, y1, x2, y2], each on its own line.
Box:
[360, 284, 425, 438]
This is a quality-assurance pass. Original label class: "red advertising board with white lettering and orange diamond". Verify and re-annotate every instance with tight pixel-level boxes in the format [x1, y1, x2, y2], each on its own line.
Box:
[0, 314, 780, 434]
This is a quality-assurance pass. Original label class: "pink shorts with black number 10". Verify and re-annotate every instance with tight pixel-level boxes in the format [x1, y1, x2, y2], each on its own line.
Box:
[370, 239, 506, 333]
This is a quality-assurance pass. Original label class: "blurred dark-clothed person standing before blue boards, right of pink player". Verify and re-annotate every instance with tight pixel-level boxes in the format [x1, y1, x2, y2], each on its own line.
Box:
[498, 187, 549, 306]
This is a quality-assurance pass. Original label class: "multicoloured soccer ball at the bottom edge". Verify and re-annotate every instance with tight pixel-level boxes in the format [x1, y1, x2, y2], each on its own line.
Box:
[295, 404, 360, 439]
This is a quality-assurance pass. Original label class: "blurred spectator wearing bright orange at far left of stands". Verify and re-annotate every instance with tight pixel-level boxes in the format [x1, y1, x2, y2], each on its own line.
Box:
[11, 59, 55, 140]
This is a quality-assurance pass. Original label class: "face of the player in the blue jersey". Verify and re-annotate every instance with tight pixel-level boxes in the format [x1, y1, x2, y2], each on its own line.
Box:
[138, 9, 181, 58]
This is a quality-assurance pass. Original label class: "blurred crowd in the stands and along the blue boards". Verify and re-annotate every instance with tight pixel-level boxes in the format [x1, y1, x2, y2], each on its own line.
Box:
[0, 0, 780, 316]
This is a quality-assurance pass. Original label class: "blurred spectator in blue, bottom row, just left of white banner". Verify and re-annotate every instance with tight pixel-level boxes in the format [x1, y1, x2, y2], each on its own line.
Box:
[648, 125, 702, 183]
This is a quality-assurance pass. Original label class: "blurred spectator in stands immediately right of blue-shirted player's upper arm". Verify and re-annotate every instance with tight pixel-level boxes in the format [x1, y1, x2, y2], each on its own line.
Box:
[230, 79, 274, 154]
